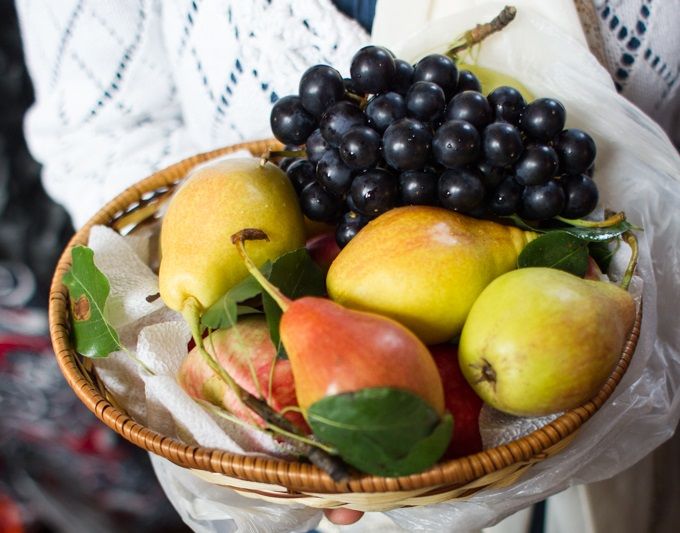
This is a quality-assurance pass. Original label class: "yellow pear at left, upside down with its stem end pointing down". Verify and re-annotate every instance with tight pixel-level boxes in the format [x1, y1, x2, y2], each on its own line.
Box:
[159, 158, 305, 312]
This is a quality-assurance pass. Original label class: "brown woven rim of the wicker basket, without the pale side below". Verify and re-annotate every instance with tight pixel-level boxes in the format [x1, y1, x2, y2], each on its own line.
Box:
[48, 139, 642, 494]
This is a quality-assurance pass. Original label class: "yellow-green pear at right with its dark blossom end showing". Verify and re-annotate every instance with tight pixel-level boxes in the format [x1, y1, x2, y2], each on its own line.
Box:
[458, 267, 635, 416]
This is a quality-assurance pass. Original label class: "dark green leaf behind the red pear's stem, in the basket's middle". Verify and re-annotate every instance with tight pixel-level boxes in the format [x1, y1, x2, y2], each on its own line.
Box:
[262, 248, 326, 348]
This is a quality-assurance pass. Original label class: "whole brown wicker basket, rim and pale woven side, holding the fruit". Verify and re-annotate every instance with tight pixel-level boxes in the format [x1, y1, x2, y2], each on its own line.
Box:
[49, 140, 641, 511]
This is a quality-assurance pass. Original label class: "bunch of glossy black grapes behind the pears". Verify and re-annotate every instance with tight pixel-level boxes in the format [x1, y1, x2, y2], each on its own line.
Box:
[270, 46, 598, 247]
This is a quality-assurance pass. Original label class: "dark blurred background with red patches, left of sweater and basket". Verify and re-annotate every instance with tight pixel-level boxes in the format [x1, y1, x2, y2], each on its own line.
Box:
[0, 4, 188, 533]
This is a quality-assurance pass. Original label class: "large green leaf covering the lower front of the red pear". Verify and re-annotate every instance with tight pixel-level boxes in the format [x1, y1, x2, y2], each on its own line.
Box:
[307, 387, 453, 476]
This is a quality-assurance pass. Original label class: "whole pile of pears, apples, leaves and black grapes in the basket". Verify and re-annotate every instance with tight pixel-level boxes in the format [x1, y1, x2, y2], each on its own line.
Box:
[64, 8, 637, 481]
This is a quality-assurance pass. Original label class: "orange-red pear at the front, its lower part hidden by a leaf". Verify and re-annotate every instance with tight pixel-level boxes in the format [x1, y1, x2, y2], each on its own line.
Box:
[280, 297, 444, 415]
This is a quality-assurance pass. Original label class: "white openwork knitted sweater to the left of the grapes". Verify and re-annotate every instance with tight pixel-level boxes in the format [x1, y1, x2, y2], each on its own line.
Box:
[17, 0, 368, 227]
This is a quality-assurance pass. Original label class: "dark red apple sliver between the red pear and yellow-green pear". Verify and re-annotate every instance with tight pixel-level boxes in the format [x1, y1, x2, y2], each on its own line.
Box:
[429, 344, 482, 459]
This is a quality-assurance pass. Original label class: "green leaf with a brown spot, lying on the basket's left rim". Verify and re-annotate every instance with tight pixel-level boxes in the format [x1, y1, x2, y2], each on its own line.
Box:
[62, 246, 122, 357]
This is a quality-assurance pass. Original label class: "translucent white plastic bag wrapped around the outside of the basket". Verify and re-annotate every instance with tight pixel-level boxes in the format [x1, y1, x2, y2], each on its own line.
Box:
[98, 4, 680, 532]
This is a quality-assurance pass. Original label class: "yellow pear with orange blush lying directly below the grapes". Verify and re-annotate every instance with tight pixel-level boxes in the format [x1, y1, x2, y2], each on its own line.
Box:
[326, 206, 536, 344]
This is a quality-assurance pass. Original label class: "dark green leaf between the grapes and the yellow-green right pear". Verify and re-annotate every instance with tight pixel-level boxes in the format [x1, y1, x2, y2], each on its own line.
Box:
[517, 231, 588, 277]
